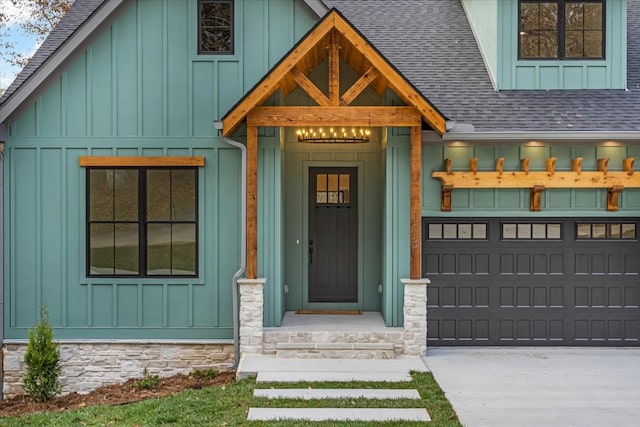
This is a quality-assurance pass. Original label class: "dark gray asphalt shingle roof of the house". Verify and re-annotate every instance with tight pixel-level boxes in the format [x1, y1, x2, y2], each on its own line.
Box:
[0, 0, 640, 132]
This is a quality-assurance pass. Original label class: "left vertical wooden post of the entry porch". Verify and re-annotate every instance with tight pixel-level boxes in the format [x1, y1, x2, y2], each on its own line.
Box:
[246, 126, 258, 279]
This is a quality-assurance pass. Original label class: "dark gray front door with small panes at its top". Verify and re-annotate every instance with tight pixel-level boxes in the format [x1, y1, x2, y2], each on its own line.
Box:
[308, 168, 358, 302]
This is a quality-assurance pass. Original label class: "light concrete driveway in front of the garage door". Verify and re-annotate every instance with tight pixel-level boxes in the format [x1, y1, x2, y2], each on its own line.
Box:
[425, 347, 640, 427]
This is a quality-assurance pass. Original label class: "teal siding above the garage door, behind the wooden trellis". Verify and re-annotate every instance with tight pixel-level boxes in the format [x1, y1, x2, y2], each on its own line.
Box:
[422, 142, 640, 217]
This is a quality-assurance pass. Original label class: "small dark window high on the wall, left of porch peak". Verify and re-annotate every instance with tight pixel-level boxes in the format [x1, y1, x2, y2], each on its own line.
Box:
[198, 0, 233, 54]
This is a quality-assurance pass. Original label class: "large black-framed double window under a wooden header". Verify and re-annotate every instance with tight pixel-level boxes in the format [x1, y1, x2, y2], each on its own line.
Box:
[87, 167, 198, 277]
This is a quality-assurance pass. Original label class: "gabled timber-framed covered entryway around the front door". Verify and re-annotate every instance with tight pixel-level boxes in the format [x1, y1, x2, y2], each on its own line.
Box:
[222, 9, 446, 332]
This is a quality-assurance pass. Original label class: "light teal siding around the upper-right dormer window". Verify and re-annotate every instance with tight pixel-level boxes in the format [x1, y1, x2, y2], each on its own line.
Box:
[496, 0, 627, 90]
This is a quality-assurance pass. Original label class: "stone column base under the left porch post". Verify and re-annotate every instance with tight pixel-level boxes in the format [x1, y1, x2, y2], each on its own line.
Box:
[238, 279, 266, 355]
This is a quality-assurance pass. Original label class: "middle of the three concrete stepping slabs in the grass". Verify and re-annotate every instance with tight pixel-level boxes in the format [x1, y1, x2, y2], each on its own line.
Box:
[253, 388, 420, 400]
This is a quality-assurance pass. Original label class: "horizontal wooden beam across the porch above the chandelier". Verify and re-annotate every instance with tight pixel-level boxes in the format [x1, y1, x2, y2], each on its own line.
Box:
[247, 107, 421, 127]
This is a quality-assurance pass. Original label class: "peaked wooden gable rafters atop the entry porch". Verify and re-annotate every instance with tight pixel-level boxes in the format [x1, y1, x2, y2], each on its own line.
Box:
[222, 9, 446, 135]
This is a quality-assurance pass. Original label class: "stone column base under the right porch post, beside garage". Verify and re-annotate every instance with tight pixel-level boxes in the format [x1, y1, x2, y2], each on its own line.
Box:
[400, 278, 431, 356]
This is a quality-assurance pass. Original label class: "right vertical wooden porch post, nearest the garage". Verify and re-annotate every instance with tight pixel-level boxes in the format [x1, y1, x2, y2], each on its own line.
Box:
[409, 126, 422, 279]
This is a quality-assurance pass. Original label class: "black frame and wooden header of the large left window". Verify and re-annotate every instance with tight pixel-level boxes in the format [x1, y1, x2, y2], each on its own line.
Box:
[81, 166, 204, 279]
